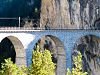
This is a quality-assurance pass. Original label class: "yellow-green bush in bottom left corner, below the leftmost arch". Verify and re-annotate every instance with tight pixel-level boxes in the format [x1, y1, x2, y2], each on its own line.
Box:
[0, 58, 27, 75]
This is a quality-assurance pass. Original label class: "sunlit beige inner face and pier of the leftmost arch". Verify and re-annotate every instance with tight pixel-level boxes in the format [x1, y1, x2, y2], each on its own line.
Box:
[1, 36, 26, 66]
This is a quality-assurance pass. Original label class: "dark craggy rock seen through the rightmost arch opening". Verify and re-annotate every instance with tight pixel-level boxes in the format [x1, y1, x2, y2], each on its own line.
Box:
[73, 35, 100, 75]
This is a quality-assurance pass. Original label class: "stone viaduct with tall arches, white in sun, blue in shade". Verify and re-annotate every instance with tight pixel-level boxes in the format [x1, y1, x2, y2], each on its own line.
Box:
[0, 30, 100, 75]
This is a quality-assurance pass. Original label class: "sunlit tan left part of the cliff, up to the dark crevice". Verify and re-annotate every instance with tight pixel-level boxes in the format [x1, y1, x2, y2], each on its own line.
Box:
[40, 0, 70, 29]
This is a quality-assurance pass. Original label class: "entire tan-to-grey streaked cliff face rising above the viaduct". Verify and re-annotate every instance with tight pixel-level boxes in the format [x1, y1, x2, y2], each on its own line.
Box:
[40, 0, 100, 29]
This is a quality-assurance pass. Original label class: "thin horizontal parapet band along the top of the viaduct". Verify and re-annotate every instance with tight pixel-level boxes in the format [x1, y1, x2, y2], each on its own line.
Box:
[0, 27, 100, 33]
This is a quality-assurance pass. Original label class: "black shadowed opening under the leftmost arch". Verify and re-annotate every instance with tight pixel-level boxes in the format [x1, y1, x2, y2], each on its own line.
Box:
[0, 37, 16, 67]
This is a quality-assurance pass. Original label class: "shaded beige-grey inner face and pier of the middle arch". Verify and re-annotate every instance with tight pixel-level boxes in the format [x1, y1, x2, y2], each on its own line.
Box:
[33, 35, 66, 75]
